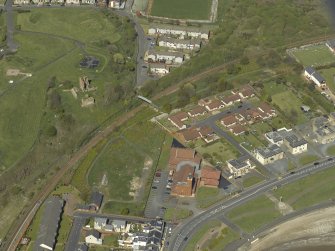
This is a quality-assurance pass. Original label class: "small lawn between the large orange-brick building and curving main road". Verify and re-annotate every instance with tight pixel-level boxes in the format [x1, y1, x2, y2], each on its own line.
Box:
[195, 187, 224, 208]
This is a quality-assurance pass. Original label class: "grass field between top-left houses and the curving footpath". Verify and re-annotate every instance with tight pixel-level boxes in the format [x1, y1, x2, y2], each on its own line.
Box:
[17, 8, 122, 44]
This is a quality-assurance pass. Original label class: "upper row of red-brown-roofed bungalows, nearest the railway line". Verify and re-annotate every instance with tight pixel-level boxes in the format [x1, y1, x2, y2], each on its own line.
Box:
[168, 85, 258, 130]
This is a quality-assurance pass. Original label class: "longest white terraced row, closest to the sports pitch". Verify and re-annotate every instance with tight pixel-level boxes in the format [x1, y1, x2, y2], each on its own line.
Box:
[148, 24, 209, 40]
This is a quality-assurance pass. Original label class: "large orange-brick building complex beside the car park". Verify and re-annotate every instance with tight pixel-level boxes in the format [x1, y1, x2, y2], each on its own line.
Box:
[168, 146, 221, 197]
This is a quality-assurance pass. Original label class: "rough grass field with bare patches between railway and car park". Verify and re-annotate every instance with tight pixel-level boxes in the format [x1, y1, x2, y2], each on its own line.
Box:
[86, 109, 165, 211]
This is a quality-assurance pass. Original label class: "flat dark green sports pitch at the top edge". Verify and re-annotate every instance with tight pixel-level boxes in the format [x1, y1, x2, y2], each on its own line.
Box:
[150, 0, 212, 20]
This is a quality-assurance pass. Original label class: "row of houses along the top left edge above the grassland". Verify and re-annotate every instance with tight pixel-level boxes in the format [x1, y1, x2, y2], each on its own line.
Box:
[14, 0, 125, 9]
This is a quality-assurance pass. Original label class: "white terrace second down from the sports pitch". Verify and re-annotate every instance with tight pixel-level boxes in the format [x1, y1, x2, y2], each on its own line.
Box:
[158, 37, 201, 50]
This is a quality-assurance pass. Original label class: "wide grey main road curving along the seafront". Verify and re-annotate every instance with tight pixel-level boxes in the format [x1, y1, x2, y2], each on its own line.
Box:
[168, 158, 335, 251]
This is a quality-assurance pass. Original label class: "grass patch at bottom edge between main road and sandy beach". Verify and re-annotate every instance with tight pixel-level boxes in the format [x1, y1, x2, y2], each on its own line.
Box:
[202, 227, 239, 251]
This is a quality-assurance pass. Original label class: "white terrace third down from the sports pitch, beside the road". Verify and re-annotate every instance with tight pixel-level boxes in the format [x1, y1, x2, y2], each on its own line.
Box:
[147, 50, 184, 64]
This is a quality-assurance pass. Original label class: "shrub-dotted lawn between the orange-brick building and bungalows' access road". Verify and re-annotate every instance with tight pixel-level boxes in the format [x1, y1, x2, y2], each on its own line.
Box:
[196, 139, 239, 167]
